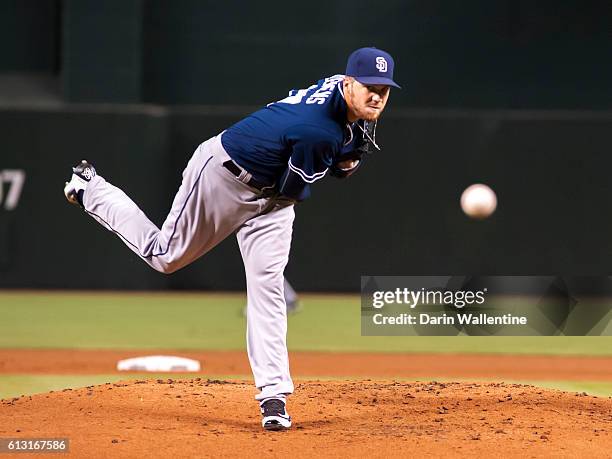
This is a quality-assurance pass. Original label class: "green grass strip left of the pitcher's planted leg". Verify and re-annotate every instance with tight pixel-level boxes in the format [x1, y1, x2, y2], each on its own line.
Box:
[0, 292, 244, 349]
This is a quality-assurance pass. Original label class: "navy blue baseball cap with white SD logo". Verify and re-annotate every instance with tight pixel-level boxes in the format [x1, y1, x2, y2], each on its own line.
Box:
[346, 48, 401, 89]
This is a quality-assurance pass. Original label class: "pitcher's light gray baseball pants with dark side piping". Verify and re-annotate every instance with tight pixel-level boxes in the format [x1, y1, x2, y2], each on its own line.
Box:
[83, 135, 295, 401]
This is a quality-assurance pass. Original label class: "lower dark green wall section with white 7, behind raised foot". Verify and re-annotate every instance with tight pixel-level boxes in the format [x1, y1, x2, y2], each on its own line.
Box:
[0, 106, 168, 288]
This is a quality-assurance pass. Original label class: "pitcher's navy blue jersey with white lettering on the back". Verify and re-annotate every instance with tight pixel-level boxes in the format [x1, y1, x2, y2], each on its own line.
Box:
[221, 75, 359, 201]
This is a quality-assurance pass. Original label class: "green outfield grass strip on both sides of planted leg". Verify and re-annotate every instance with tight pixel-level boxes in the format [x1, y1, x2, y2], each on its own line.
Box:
[0, 291, 612, 355]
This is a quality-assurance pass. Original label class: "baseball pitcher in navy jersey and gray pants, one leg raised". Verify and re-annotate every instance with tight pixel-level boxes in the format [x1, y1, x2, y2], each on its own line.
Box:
[64, 48, 399, 430]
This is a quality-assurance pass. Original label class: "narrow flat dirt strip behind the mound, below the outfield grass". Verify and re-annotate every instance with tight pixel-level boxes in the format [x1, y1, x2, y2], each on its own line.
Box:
[0, 349, 612, 381]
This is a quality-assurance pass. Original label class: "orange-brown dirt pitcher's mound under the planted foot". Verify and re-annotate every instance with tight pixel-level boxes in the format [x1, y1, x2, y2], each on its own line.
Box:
[0, 378, 612, 458]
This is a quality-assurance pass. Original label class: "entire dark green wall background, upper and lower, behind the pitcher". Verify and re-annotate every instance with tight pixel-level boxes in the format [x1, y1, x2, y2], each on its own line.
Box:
[0, 0, 612, 290]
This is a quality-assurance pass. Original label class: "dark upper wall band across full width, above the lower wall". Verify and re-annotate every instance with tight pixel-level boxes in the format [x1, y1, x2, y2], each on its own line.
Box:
[0, 0, 612, 109]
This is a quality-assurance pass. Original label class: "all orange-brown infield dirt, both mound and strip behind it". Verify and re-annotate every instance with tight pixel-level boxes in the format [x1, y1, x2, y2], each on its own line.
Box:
[0, 349, 612, 458]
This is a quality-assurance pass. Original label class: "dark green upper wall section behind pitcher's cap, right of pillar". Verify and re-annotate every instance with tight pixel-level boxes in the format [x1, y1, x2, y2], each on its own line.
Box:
[139, 0, 612, 108]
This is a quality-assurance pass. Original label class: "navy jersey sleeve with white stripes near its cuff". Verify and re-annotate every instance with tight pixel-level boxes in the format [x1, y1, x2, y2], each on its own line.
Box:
[279, 125, 338, 201]
